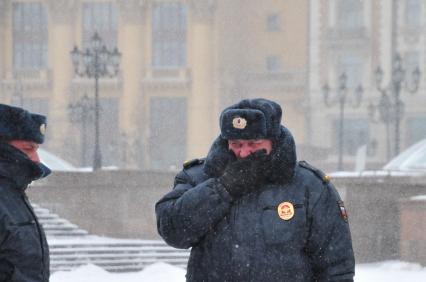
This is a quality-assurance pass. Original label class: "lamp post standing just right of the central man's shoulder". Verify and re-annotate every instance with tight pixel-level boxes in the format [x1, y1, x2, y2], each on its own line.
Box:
[322, 73, 364, 171]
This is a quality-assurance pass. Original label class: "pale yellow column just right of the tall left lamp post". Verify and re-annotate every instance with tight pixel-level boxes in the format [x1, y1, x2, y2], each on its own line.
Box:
[117, 0, 146, 168]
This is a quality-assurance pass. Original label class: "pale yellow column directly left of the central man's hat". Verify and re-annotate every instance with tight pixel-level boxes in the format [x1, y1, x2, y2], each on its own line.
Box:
[187, 0, 219, 158]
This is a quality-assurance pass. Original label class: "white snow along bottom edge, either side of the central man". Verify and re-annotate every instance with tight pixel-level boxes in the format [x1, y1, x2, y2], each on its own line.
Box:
[51, 261, 426, 282]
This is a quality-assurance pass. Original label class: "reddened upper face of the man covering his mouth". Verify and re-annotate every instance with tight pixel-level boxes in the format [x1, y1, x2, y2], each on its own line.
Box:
[228, 139, 272, 159]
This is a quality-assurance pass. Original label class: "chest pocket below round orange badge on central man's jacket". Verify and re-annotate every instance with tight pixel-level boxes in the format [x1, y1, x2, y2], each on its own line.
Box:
[262, 204, 306, 245]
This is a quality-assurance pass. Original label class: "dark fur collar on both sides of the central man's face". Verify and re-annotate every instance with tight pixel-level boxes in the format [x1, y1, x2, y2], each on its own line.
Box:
[204, 126, 297, 184]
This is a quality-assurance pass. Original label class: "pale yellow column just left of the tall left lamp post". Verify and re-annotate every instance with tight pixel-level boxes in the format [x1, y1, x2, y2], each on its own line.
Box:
[47, 0, 76, 158]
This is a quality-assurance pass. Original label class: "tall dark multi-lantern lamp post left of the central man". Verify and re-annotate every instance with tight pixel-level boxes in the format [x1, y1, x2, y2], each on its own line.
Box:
[71, 33, 121, 170]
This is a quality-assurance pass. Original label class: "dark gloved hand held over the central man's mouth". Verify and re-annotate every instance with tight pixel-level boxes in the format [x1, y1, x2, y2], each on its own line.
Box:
[218, 150, 269, 198]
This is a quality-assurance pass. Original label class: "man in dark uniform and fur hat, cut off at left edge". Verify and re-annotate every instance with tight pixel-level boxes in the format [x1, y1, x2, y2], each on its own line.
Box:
[0, 104, 50, 282]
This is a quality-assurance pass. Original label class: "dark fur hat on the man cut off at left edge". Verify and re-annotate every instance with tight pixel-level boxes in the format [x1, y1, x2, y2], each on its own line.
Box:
[0, 104, 46, 144]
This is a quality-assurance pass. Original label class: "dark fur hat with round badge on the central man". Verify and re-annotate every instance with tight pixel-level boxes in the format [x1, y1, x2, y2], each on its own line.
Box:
[220, 98, 282, 139]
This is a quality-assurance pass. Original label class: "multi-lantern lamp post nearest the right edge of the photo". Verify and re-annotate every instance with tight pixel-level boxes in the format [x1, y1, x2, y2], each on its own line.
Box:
[369, 54, 421, 156]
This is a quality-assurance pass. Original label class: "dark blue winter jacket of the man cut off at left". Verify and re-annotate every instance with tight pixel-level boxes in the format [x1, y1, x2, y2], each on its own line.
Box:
[0, 142, 49, 282]
